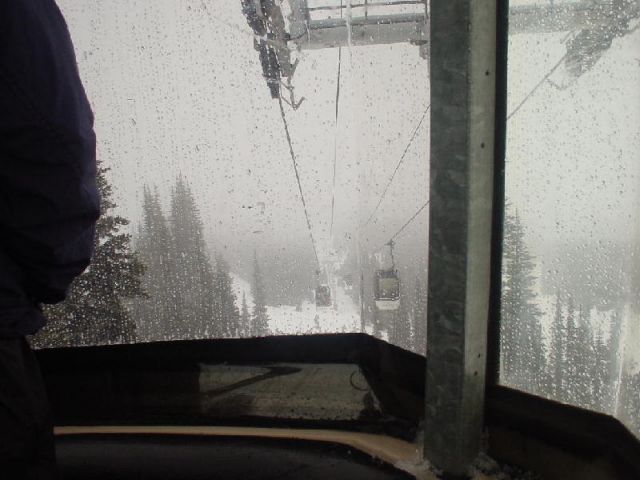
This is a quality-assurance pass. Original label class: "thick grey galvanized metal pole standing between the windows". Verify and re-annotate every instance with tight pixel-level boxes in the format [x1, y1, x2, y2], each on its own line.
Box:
[425, 0, 496, 478]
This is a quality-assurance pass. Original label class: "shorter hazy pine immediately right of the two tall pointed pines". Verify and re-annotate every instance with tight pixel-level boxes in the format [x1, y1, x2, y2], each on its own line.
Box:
[212, 255, 240, 337]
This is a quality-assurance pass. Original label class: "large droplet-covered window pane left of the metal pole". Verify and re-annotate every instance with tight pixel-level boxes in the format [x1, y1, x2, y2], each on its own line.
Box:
[35, 0, 429, 352]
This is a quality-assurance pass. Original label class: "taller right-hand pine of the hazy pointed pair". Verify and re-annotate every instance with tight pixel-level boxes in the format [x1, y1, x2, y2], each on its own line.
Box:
[169, 176, 216, 338]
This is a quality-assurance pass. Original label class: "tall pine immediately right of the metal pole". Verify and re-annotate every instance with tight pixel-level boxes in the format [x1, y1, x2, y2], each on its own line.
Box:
[501, 206, 546, 392]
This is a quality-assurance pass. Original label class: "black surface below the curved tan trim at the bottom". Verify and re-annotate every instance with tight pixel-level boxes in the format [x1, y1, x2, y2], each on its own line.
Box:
[57, 435, 413, 480]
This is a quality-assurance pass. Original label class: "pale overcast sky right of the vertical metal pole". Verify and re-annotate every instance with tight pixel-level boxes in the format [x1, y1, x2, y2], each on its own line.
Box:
[507, 30, 640, 251]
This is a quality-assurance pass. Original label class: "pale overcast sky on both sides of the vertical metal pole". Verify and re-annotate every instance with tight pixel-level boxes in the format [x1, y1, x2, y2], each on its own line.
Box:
[60, 0, 640, 255]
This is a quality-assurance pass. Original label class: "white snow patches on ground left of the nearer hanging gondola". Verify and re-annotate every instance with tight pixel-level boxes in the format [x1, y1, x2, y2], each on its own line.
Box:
[231, 273, 361, 335]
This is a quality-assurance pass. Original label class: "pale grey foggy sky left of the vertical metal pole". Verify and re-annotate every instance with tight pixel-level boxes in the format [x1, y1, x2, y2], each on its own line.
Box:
[61, 0, 429, 270]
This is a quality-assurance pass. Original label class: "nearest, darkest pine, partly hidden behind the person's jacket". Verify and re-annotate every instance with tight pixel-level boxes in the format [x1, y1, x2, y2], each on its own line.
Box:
[34, 164, 144, 346]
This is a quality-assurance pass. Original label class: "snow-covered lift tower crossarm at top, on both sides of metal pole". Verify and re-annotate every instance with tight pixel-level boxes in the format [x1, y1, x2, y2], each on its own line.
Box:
[240, 0, 640, 103]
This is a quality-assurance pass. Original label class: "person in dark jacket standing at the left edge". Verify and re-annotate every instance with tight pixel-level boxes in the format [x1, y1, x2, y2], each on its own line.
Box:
[0, 0, 99, 479]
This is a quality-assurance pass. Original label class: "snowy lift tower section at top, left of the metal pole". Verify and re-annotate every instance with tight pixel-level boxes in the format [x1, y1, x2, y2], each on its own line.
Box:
[240, 0, 429, 105]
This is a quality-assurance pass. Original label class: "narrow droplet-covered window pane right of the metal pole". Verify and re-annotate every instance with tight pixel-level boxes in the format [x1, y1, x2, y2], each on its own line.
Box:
[500, 1, 640, 435]
